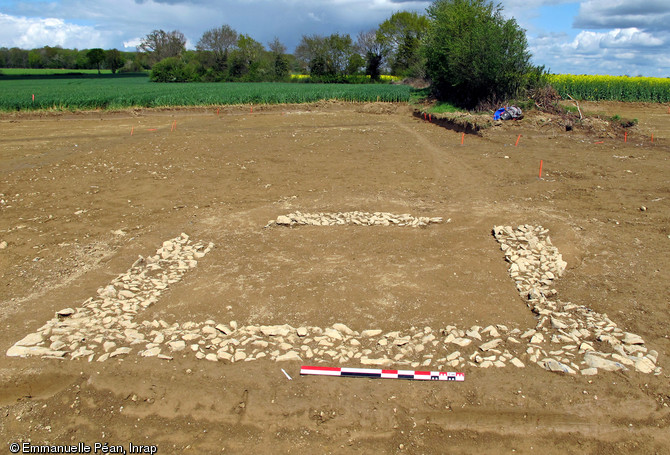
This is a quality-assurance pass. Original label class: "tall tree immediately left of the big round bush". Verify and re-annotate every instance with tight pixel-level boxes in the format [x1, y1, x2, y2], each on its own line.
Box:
[377, 11, 429, 77]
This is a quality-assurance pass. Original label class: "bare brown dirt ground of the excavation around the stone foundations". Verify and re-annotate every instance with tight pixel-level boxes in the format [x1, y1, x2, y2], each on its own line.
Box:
[0, 103, 670, 454]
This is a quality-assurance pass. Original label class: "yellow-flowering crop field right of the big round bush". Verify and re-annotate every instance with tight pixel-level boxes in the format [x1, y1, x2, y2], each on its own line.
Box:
[549, 74, 670, 103]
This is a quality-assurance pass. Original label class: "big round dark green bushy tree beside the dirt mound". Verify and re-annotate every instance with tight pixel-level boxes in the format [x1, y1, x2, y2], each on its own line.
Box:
[424, 0, 543, 107]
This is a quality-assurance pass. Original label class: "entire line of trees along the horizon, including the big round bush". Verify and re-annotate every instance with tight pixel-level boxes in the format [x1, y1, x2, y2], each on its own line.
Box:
[0, 0, 547, 107]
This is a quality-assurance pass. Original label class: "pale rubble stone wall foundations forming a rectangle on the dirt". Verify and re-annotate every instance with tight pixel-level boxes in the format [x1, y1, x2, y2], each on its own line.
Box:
[7, 228, 661, 382]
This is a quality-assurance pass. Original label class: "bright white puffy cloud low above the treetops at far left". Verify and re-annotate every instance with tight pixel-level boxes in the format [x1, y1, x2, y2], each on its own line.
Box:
[0, 13, 106, 49]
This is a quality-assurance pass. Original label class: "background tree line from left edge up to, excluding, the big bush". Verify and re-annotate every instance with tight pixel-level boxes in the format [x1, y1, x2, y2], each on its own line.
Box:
[0, 11, 427, 81]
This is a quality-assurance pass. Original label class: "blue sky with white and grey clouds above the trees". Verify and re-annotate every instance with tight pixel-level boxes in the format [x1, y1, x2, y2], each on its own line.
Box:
[0, 0, 670, 77]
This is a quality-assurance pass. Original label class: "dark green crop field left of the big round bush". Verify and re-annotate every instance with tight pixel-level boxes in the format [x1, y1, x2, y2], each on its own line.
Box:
[0, 75, 410, 111]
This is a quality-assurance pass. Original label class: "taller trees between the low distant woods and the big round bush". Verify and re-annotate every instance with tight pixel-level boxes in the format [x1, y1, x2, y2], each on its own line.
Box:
[144, 11, 428, 82]
